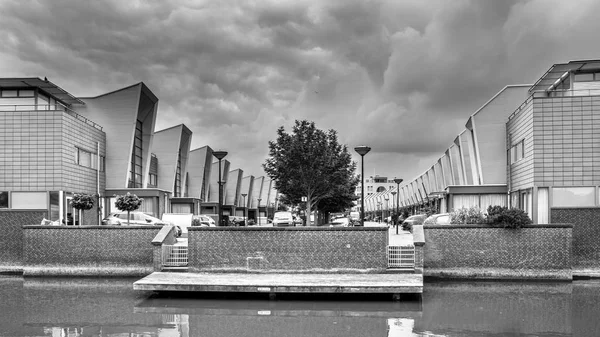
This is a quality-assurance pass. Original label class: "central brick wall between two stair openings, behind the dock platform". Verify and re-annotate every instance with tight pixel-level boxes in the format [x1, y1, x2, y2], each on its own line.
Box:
[188, 227, 388, 273]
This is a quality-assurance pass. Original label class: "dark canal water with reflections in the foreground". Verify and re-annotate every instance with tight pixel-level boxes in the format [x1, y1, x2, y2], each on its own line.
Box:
[0, 276, 600, 337]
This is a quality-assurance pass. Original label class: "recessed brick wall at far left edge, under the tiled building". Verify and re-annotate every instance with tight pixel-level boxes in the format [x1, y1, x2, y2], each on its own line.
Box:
[0, 210, 47, 272]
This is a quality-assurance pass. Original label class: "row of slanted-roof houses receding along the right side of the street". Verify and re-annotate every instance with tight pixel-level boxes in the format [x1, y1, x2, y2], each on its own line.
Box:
[365, 60, 600, 224]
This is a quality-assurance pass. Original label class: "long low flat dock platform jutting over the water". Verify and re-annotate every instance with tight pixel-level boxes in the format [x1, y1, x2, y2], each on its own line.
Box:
[133, 272, 423, 294]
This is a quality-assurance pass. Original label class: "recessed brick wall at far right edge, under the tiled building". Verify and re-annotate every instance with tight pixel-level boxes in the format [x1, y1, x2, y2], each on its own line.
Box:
[550, 208, 600, 269]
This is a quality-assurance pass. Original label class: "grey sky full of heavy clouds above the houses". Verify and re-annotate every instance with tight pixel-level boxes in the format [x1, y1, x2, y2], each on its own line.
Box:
[0, 0, 600, 180]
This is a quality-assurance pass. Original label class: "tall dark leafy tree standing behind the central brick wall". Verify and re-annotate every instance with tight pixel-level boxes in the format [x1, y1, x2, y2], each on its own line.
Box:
[263, 120, 358, 225]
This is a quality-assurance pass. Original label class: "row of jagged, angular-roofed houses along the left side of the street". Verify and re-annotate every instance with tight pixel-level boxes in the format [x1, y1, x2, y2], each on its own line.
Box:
[0, 78, 277, 224]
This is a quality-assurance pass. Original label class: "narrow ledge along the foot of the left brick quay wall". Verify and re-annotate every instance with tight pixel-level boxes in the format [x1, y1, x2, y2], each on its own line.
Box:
[23, 266, 154, 277]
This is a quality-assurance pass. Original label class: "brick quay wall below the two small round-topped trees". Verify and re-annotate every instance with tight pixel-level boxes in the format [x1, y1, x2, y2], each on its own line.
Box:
[23, 226, 161, 276]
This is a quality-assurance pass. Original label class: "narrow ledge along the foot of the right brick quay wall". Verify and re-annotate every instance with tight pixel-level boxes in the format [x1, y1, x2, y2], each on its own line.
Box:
[424, 268, 573, 282]
